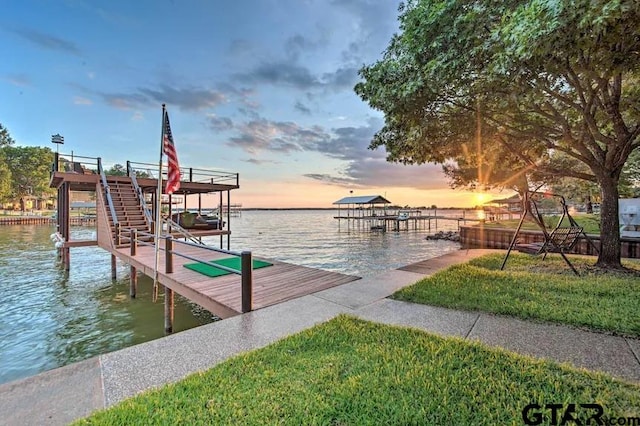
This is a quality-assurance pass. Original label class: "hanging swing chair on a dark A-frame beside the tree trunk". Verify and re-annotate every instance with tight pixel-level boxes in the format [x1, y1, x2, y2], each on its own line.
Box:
[500, 191, 598, 275]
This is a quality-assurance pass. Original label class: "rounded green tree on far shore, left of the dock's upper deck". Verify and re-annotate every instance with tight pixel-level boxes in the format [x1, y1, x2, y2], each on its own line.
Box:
[2, 146, 53, 211]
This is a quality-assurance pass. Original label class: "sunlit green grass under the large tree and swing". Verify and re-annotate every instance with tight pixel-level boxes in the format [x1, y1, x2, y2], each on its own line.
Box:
[392, 253, 640, 337]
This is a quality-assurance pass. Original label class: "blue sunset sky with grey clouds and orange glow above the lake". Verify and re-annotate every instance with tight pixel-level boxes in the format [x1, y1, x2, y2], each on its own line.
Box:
[0, 0, 490, 207]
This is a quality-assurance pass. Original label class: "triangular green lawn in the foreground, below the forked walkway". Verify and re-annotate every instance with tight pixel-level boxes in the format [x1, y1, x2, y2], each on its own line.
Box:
[77, 316, 640, 425]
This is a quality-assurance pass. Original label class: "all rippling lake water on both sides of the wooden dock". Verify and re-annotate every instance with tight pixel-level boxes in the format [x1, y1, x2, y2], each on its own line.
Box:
[0, 210, 473, 383]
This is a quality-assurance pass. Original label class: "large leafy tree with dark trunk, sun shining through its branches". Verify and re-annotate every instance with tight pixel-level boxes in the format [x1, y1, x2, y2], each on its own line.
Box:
[355, 0, 640, 268]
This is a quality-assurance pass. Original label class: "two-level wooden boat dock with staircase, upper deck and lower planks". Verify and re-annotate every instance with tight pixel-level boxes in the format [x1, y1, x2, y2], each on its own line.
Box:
[50, 153, 359, 333]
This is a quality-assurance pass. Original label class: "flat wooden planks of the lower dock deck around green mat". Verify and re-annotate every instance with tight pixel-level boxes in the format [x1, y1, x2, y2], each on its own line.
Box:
[114, 242, 359, 318]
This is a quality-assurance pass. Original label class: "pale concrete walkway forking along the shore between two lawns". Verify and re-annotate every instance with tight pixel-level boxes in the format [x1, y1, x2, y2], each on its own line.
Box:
[0, 250, 640, 425]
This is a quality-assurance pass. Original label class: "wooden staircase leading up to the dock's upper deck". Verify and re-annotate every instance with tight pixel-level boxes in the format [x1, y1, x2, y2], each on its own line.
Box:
[107, 178, 153, 248]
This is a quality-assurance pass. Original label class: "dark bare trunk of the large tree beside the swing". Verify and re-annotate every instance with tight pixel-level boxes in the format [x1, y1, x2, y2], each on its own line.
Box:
[596, 178, 622, 269]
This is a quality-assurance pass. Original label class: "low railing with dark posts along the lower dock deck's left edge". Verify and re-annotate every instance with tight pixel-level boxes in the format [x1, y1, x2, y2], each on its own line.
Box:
[119, 228, 253, 313]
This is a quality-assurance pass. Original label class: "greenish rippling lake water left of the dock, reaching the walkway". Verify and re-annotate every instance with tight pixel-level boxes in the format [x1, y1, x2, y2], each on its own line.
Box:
[0, 226, 214, 383]
